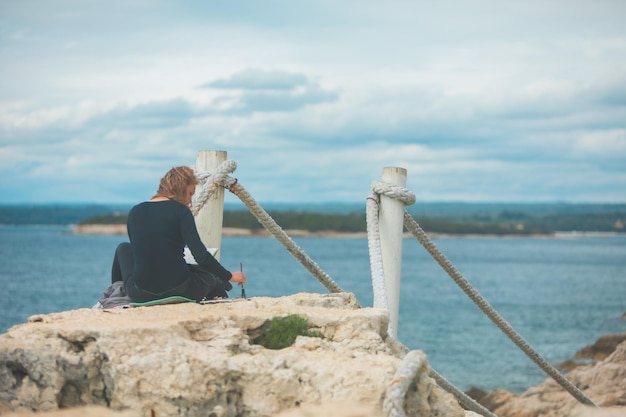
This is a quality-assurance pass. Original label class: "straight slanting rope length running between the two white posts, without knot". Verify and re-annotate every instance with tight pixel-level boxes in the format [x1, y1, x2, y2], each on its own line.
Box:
[228, 181, 344, 293]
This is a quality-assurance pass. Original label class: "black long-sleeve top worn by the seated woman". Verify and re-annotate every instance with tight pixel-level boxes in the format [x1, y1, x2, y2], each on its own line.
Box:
[127, 200, 232, 294]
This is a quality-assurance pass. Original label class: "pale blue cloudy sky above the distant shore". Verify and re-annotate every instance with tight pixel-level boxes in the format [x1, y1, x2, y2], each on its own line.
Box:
[0, 0, 626, 203]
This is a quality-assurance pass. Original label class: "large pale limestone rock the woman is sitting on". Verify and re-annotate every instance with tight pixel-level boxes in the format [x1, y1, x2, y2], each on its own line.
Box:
[0, 294, 465, 417]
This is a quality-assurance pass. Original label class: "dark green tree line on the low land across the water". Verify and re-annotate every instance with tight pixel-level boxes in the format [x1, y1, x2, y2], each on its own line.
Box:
[81, 210, 626, 235]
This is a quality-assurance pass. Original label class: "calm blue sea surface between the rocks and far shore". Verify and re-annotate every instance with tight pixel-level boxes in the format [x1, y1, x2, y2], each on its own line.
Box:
[0, 226, 626, 392]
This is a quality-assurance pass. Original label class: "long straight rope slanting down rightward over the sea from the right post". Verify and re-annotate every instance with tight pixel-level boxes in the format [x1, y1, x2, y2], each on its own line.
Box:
[404, 210, 596, 406]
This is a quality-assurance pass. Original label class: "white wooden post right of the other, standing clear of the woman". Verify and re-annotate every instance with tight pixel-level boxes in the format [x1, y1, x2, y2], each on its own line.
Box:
[379, 167, 406, 338]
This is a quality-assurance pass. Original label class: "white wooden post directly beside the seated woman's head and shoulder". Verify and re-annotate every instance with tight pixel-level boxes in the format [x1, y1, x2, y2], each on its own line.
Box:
[196, 151, 226, 261]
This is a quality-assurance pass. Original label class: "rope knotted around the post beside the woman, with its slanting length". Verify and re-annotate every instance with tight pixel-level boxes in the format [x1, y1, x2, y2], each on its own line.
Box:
[192, 160, 344, 293]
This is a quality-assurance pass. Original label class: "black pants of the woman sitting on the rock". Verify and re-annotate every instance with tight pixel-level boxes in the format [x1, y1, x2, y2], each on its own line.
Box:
[111, 242, 228, 303]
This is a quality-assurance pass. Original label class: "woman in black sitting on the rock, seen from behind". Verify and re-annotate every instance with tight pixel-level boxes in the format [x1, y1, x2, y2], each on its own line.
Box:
[111, 166, 246, 302]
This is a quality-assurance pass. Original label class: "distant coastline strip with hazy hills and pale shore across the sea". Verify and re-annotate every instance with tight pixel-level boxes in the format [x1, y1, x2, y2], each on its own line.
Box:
[0, 203, 626, 238]
